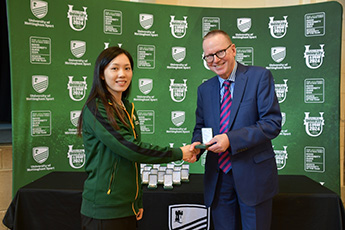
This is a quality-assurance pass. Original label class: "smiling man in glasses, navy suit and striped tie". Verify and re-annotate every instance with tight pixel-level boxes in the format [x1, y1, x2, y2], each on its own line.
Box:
[191, 30, 281, 230]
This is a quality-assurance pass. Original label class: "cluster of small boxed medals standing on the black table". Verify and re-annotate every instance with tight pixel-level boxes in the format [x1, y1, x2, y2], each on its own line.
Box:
[140, 163, 189, 190]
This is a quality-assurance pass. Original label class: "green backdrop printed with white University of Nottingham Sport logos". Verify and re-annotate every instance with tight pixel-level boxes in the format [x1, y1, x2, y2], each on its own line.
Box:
[7, 0, 342, 193]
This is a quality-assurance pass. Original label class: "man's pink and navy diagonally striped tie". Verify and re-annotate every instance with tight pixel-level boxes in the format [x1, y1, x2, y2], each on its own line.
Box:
[218, 81, 232, 173]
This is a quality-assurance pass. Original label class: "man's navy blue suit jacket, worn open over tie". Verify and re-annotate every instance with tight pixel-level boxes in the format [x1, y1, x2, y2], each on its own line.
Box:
[192, 63, 281, 207]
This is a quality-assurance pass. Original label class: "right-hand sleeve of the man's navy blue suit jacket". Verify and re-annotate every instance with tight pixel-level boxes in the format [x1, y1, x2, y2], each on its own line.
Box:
[227, 68, 281, 155]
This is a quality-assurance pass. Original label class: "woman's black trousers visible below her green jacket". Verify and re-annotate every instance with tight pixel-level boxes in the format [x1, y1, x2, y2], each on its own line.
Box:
[81, 215, 137, 230]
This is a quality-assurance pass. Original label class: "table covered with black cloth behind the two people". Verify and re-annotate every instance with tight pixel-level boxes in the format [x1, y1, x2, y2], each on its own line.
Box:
[3, 172, 345, 230]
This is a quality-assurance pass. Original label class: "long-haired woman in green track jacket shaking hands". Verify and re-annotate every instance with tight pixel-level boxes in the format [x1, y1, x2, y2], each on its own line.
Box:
[78, 47, 195, 230]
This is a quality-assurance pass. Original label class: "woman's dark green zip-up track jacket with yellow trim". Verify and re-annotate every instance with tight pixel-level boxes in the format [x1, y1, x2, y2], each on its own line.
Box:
[81, 99, 182, 219]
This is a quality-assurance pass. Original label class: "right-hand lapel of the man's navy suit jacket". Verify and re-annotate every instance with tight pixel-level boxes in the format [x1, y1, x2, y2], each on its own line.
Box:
[230, 63, 248, 129]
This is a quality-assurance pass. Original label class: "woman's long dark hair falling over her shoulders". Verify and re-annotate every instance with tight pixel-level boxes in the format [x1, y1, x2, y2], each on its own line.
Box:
[77, 46, 134, 136]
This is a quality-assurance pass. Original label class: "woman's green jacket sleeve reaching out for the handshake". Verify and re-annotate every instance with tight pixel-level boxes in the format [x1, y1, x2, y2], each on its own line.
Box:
[83, 100, 182, 163]
